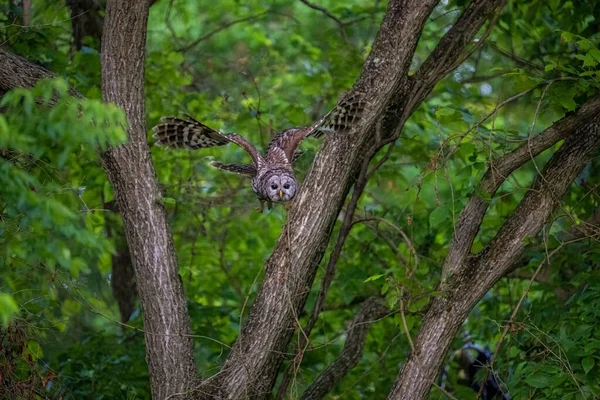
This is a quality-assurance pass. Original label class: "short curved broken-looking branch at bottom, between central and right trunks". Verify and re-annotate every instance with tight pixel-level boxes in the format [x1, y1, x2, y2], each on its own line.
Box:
[302, 297, 390, 400]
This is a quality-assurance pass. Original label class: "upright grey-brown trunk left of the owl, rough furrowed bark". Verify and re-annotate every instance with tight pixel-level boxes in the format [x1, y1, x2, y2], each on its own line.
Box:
[102, 0, 196, 399]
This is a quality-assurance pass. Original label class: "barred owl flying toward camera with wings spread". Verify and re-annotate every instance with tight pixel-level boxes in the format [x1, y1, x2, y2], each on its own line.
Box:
[153, 96, 364, 208]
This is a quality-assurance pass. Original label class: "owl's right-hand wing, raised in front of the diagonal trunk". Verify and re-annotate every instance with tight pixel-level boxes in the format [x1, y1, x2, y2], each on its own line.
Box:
[266, 95, 365, 162]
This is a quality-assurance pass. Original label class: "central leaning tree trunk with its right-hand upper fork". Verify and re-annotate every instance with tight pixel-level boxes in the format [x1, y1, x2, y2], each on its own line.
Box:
[211, 0, 504, 399]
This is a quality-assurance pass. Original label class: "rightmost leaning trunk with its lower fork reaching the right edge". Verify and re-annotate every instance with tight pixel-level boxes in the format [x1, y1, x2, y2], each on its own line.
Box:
[388, 111, 600, 400]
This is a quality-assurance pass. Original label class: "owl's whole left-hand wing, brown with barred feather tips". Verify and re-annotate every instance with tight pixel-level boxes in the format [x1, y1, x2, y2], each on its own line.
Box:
[152, 115, 264, 168]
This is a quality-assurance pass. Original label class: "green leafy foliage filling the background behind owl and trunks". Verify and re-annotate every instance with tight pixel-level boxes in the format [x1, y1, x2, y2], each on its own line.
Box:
[0, 0, 600, 399]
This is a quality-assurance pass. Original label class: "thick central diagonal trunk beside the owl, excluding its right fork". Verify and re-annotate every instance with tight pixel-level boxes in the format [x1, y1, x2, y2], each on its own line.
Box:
[206, 0, 436, 398]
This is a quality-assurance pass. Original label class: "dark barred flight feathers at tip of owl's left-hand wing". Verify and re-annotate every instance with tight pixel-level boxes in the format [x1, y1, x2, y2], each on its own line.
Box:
[152, 116, 230, 149]
